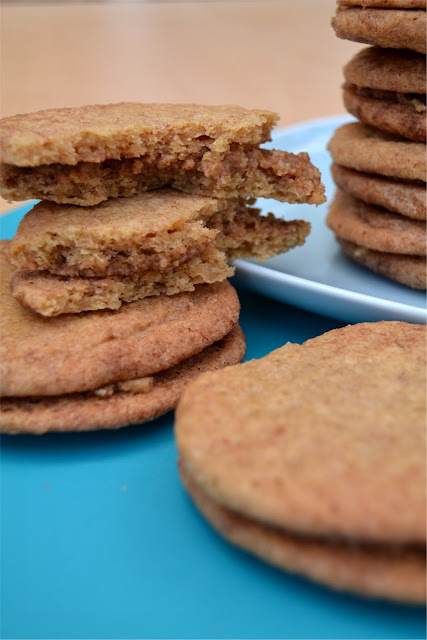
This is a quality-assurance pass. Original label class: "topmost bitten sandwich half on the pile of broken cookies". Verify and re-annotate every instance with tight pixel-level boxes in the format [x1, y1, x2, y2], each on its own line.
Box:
[0, 103, 325, 206]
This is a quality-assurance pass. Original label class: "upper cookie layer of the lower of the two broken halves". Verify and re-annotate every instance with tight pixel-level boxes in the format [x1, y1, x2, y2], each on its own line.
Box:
[11, 189, 226, 276]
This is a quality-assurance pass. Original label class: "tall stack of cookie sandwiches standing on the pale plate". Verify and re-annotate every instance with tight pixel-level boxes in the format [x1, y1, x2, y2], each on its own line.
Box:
[327, 0, 426, 289]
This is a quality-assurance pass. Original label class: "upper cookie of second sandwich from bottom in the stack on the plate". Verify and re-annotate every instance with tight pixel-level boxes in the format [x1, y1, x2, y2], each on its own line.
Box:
[328, 122, 426, 182]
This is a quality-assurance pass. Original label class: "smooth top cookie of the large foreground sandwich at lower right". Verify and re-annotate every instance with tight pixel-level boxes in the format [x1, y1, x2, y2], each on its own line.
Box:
[176, 322, 426, 543]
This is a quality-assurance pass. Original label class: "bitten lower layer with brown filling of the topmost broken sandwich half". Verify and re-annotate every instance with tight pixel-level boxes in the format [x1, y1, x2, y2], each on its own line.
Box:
[0, 144, 325, 206]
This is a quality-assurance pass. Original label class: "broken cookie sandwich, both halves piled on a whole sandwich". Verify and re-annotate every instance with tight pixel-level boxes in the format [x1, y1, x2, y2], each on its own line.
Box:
[0, 103, 325, 316]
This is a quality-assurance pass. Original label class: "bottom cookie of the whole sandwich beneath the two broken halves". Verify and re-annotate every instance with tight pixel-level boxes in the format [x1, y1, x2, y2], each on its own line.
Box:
[0, 325, 246, 435]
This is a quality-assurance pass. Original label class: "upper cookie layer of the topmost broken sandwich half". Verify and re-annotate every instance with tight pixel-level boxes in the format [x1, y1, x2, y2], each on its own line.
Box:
[0, 102, 278, 167]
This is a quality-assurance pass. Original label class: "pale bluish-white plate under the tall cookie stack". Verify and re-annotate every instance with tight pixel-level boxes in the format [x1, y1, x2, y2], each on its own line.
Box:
[235, 116, 427, 323]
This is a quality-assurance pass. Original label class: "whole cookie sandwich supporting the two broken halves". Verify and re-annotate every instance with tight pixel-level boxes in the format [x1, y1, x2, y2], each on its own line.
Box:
[0, 241, 245, 434]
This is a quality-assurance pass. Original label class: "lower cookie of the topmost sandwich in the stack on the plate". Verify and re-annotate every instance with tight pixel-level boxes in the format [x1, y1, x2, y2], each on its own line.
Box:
[332, 7, 426, 53]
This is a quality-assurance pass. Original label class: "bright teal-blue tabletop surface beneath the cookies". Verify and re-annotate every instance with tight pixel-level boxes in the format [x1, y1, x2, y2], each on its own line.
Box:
[0, 207, 426, 639]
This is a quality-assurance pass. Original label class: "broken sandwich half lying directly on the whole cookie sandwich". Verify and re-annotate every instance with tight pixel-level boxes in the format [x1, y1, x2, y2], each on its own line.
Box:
[11, 189, 310, 316]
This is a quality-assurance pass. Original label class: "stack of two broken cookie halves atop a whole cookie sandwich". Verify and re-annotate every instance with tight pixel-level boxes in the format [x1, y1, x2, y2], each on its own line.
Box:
[0, 103, 325, 433]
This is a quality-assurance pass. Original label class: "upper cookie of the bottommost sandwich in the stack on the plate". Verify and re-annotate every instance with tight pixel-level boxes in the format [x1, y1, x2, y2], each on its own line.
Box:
[326, 189, 426, 256]
